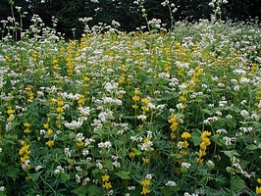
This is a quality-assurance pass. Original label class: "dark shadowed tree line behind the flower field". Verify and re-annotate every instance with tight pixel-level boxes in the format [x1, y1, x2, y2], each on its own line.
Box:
[0, 0, 261, 37]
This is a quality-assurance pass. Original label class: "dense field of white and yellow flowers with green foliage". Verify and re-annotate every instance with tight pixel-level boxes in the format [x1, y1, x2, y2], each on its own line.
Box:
[0, 13, 261, 196]
